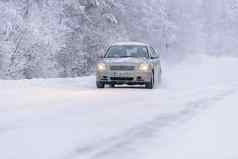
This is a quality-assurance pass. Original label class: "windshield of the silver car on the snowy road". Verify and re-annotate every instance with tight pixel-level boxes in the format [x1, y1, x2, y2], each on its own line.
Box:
[106, 46, 148, 58]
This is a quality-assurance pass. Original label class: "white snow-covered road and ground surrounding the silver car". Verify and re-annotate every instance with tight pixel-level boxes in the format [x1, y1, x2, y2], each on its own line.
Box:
[0, 56, 238, 159]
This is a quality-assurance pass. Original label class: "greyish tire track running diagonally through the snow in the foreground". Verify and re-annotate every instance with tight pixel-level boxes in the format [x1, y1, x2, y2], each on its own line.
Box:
[64, 88, 237, 159]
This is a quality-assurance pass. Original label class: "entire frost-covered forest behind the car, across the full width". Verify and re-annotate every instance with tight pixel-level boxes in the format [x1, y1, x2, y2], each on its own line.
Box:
[0, 0, 238, 79]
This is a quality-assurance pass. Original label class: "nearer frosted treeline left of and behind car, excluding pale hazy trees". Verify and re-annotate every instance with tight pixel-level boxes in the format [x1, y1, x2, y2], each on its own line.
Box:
[0, 0, 169, 79]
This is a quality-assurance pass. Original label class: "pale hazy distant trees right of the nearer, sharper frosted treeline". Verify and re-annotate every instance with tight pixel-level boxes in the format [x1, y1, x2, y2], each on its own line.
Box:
[167, 0, 238, 57]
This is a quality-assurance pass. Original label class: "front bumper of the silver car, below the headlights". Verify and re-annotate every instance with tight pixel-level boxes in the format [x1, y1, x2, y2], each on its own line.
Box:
[96, 71, 152, 85]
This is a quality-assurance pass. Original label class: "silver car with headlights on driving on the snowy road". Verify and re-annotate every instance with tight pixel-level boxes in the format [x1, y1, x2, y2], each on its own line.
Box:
[96, 42, 161, 89]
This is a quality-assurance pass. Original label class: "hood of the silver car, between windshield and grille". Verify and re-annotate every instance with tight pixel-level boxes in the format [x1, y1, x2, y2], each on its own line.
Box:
[103, 58, 146, 65]
